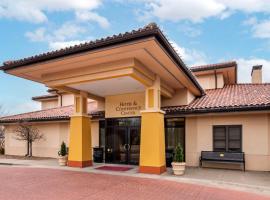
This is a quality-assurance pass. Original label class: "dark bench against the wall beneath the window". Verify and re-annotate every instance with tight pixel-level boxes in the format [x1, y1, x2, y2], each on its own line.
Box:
[200, 151, 245, 171]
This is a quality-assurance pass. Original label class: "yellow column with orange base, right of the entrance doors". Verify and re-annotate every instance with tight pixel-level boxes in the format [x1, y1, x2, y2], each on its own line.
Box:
[139, 77, 166, 174]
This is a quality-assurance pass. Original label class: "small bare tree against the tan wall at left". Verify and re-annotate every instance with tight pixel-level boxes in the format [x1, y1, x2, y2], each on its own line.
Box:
[14, 123, 44, 157]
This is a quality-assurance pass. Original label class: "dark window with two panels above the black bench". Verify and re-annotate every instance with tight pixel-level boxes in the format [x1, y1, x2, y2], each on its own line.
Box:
[213, 125, 242, 152]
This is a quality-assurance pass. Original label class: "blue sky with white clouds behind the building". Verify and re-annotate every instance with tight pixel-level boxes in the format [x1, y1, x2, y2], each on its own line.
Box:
[0, 0, 270, 114]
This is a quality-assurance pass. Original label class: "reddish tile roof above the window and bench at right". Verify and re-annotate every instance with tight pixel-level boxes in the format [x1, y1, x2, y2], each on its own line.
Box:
[163, 83, 270, 114]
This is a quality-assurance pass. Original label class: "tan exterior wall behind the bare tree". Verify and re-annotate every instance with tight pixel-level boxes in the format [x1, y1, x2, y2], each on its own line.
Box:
[5, 122, 69, 158]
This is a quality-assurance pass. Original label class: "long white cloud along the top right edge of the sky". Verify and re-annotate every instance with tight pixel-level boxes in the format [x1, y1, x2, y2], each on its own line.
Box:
[137, 0, 270, 22]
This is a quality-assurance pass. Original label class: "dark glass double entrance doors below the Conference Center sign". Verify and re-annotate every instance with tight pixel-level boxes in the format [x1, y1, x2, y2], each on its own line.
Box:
[105, 117, 141, 165]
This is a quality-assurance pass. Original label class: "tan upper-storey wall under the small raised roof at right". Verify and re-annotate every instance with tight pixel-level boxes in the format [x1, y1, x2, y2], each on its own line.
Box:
[197, 74, 224, 89]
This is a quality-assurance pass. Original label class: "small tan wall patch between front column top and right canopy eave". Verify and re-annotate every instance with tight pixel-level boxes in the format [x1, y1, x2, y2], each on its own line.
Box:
[161, 89, 195, 106]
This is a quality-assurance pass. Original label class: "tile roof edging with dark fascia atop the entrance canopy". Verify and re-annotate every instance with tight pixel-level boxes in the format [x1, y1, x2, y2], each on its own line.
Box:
[0, 23, 204, 95]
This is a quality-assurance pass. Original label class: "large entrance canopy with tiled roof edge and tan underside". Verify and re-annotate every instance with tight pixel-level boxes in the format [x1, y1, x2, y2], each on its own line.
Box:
[1, 24, 204, 99]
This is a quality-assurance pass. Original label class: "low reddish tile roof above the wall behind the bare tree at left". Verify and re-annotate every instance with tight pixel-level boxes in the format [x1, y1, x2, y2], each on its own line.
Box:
[0, 106, 104, 123]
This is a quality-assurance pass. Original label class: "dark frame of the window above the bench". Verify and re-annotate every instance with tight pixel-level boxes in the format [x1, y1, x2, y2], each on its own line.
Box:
[212, 125, 243, 153]
